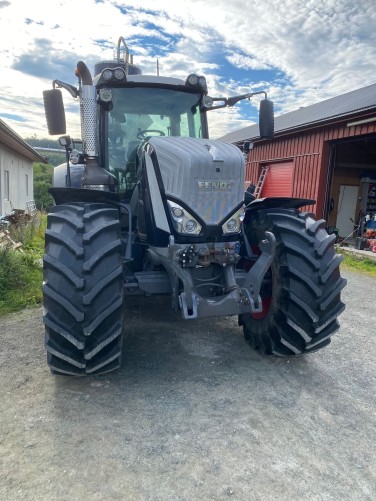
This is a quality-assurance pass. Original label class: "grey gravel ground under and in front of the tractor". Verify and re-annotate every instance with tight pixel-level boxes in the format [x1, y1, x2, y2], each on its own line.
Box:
[0, 272, 376, 501]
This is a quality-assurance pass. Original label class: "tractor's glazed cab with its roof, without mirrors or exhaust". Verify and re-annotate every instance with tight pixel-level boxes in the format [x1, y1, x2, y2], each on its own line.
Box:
[94, 72, 208, 193]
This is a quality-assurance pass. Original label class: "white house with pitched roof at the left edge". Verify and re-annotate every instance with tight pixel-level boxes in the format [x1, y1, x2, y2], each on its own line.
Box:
[0, 119, 45, 215]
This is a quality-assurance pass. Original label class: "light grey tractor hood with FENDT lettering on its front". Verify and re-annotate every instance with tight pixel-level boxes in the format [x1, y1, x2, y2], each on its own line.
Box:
[148, 137, 245, 225]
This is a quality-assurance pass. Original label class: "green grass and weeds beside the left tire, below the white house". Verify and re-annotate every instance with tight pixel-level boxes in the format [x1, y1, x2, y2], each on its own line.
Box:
[0, 214, 47, 316]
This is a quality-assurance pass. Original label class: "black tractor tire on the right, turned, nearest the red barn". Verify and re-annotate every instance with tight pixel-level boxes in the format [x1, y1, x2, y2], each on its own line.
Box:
[239, 209, 346, 356]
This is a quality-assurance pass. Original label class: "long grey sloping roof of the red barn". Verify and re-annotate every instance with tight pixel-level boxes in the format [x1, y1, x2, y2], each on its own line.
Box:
[219, 84, 376, 143]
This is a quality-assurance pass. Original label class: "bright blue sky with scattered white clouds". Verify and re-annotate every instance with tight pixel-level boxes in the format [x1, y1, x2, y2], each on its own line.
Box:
[0, 0, 376, 138]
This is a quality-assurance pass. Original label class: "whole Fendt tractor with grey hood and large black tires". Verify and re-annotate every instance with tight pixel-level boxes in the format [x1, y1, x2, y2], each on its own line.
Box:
[43, 37, 345, 375]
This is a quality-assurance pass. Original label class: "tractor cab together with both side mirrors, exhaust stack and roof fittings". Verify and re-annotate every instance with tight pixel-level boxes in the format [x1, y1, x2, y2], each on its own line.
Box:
[43, 37, 274, 194]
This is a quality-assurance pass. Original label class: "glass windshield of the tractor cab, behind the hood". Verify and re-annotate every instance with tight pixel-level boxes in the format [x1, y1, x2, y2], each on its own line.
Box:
[105, 87, 205, 191]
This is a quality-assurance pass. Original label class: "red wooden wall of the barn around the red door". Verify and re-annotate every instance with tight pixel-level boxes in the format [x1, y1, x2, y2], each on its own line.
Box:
[246, 117, 376, 217]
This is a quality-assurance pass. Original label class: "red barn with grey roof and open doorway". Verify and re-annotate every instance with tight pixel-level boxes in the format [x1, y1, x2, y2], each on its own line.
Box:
[221, 84, 376, 237]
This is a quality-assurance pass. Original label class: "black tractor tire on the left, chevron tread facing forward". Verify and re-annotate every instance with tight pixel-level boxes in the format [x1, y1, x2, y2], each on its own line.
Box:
[43, 203, 124, 376]
